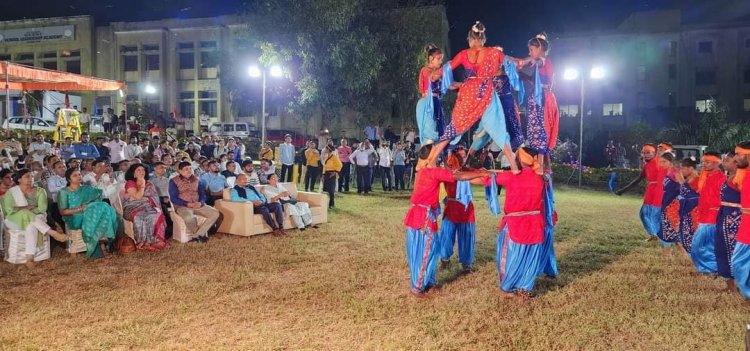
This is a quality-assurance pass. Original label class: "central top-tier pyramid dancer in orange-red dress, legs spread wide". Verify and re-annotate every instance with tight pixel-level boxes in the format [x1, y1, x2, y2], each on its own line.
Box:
[429, 22, 513, 168]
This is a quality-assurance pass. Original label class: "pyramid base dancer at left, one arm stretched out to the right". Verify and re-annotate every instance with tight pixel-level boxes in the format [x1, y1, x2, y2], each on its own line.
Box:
[404, 145, 487, 297]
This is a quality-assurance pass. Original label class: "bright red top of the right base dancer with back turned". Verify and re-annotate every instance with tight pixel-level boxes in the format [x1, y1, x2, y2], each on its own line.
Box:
[496, 168, 544, 245]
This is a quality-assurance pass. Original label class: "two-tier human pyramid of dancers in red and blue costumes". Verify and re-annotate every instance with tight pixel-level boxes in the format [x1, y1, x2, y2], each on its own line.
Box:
[404, 22, 559, 299]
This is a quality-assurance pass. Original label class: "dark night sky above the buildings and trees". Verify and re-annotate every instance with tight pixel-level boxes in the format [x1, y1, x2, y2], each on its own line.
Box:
[0, 0, 750, 56]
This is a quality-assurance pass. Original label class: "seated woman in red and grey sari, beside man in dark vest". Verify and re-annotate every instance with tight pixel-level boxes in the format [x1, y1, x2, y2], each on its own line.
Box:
[122, 164, 167, 252]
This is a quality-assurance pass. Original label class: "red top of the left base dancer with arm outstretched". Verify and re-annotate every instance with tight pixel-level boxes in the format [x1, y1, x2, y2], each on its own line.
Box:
[404, 167, 455, 231]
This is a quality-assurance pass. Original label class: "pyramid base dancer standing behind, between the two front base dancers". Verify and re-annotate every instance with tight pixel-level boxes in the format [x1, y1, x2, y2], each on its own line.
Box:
[440, 148, 476, 272]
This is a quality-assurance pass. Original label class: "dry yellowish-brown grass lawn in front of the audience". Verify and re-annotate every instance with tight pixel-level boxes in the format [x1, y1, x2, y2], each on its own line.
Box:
[0, 189, 750, 350]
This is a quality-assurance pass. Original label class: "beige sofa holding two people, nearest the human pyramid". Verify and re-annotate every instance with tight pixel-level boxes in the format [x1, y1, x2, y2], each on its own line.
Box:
[216, 183, 328, 236]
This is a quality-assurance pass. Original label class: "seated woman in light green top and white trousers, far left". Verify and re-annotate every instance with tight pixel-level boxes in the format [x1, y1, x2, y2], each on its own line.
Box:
[2, 169, 67, 267]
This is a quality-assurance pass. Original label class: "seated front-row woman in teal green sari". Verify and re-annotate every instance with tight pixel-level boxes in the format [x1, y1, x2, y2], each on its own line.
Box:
[57, 168, 117, 258]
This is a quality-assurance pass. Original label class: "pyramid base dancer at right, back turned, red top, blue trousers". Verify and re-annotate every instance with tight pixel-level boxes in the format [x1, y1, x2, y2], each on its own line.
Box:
[486, 147, 548, 299]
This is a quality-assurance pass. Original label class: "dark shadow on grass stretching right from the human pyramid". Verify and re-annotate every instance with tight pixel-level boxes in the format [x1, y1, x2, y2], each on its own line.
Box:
[535, 233, 643, 296]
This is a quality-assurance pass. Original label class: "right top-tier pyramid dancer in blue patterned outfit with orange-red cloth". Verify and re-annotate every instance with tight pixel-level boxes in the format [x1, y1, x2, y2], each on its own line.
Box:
[518, 33, 560, 169]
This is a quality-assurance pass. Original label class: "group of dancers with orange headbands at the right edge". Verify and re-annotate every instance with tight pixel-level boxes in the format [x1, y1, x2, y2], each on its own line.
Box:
[615, 141, 750, 299]
